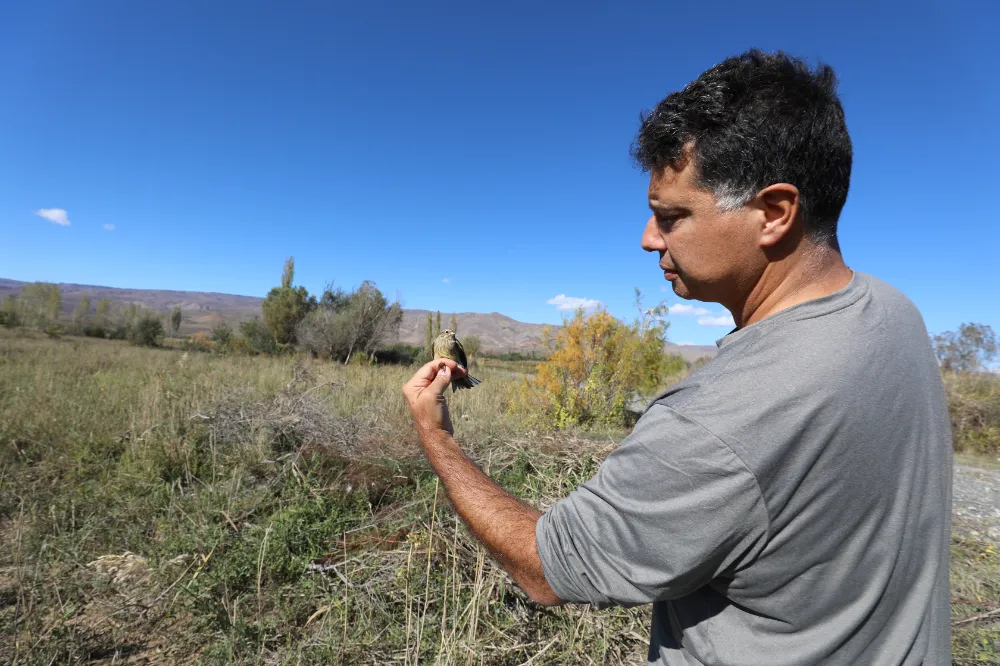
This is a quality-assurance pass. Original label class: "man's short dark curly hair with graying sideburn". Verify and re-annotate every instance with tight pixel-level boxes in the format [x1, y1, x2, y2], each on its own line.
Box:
[632, 49, 852, 248]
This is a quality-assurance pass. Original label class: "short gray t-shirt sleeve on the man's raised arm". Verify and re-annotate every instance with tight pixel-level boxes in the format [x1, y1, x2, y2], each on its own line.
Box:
[535, 405, 768, 608]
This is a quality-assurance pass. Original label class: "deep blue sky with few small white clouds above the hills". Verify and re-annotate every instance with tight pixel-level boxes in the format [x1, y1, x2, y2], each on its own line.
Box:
[0, 0, 1000, 343]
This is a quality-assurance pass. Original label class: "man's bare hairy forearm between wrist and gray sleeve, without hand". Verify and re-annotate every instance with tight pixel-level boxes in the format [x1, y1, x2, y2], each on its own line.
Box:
[421, 431, 562, 605]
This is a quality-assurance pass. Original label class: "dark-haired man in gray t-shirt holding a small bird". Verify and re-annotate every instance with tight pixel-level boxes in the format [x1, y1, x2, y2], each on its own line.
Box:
[404, 51, 951, 665]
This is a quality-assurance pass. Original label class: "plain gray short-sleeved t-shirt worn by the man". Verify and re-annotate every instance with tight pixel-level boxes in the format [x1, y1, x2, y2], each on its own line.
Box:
[536, 273, 951, 666]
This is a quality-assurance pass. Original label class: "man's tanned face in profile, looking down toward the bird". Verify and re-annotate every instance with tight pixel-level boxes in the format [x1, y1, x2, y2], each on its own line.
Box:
[642, 159, 760, 304]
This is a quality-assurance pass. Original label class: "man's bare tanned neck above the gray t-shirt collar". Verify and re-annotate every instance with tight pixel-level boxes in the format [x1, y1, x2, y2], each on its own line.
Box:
[730, 246, 854, 328]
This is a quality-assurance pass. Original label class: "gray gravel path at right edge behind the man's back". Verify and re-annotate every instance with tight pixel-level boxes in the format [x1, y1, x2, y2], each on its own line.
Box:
[952, 463, 1000, 543]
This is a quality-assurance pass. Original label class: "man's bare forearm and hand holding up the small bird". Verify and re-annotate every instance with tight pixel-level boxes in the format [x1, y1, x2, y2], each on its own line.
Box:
[403, 359, 563, 606]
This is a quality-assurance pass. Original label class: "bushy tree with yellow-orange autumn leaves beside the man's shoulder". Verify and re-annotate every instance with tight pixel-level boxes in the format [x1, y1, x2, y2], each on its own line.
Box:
[524, 289, 685, 428]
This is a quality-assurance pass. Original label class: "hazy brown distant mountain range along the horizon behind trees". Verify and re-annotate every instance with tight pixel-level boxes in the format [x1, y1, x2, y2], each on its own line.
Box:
[0, 278, 716, 361]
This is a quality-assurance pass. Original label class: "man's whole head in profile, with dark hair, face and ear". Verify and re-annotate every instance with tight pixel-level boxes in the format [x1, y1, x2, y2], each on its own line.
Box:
[632, 50, 852, 305]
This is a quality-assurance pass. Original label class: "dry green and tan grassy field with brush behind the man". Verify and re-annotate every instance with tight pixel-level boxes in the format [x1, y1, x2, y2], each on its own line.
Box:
[0, 332, 1000, 665]
